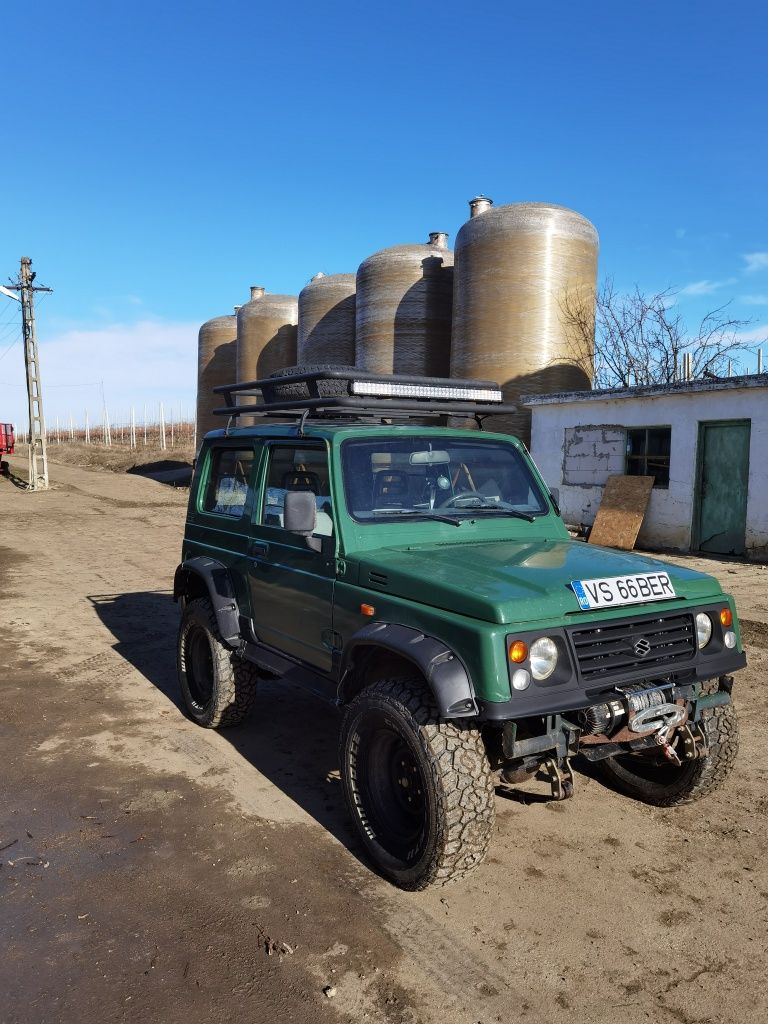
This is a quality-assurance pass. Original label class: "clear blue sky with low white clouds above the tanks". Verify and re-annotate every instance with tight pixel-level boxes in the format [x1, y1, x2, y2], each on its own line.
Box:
[0, 0, 768, 421]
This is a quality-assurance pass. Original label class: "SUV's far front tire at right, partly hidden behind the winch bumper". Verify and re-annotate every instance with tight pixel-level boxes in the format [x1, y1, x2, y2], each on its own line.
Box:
[598, 680, 738, 807]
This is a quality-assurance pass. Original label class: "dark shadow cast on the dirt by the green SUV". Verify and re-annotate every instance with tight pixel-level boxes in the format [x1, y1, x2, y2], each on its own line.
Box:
[89, 591, 371, 867]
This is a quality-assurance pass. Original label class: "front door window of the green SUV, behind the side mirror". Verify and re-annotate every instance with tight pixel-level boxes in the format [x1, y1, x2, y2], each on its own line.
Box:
[261, 444, 334, 537]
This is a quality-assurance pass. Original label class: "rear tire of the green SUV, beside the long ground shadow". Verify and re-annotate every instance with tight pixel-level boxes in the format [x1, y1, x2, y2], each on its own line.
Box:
[176, 597, 258, 729]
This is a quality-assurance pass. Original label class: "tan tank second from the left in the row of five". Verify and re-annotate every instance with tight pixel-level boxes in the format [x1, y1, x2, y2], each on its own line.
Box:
[237, 286, 299, 426]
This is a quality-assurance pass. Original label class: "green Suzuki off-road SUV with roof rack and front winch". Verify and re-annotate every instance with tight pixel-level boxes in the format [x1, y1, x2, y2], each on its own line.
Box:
[174, 368, 745, 889]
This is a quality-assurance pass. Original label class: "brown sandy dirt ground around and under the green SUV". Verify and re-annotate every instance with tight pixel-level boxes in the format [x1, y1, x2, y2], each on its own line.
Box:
[0, 460, 768, 1024]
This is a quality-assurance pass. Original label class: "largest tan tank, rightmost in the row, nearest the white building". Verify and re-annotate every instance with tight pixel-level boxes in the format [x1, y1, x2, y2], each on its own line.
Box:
[451, 196, 598, 443]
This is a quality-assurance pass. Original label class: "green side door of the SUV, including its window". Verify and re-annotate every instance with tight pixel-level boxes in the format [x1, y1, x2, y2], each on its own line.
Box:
[249, 441, 336, 673]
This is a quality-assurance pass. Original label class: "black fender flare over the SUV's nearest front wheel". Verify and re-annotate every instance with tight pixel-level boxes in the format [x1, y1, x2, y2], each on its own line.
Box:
[340, 623, 478, 718]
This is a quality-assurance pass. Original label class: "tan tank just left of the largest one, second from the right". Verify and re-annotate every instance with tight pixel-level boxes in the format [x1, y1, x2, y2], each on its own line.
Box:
[355, 231, 454, 377]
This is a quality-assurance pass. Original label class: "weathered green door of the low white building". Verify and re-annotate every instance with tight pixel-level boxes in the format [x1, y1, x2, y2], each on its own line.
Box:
[695, 420, 751, 555]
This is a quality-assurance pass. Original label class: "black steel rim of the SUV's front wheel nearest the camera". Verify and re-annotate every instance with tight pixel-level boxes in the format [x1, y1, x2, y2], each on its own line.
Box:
[355, 716, 429, 866]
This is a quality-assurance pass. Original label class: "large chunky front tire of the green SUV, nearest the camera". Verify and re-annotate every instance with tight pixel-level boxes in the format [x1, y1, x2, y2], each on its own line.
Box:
[339, 677, 496, 890]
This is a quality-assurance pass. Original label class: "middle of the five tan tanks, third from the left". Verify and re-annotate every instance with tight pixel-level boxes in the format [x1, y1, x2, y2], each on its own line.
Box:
[296, 273, 355, 367]
